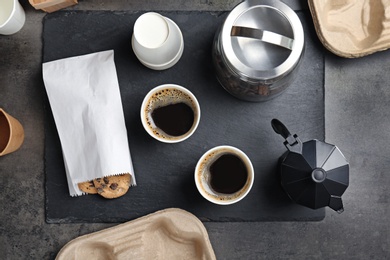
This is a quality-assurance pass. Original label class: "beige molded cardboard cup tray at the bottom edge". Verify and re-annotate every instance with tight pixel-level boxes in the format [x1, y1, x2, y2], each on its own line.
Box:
[56, 208, 216, 260]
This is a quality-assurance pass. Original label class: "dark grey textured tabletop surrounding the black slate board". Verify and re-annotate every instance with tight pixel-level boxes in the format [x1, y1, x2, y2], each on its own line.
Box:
[0, 0, 390, 259]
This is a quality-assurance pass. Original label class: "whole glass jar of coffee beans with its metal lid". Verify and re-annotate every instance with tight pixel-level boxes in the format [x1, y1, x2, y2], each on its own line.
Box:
[213, 0, 304, 102]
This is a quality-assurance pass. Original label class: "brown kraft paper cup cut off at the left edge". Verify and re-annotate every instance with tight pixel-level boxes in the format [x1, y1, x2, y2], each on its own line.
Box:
[0, 108, 24, 156]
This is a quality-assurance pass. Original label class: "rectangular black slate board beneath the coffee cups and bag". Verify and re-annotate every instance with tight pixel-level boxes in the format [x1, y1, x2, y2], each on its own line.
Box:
[43, 11, 325, 223]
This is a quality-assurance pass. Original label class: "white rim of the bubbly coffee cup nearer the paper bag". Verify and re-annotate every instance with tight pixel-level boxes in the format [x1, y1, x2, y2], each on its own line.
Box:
[140, 83, 201, 143]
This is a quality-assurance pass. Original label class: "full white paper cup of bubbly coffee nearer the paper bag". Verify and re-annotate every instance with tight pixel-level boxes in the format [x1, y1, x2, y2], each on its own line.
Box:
[141, 84, 200, 143]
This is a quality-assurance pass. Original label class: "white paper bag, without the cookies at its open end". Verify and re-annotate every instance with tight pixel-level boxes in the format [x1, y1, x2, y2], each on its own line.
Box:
[43, 50, 136, 196]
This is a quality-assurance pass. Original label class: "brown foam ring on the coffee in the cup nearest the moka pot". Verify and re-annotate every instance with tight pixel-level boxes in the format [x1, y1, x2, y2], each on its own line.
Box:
[197, 149, 251, 201]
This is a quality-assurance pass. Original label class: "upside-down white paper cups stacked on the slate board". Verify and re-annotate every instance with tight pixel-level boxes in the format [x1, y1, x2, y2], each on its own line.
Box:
[131, 12, 184, 70]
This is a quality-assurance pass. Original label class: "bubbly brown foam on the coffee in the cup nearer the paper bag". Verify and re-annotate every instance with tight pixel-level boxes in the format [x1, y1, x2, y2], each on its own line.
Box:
[144, 87, 199, 140]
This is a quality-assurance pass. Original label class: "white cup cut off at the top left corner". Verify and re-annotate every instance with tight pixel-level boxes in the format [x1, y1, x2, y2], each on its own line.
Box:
[0, 0, 26, 35]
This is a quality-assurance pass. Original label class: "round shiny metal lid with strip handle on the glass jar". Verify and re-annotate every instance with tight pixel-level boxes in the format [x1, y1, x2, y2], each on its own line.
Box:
[221, 0, 304, 81]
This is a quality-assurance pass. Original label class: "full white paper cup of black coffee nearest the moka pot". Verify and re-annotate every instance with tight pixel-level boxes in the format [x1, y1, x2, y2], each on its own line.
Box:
[195, 145, 254, 205]
